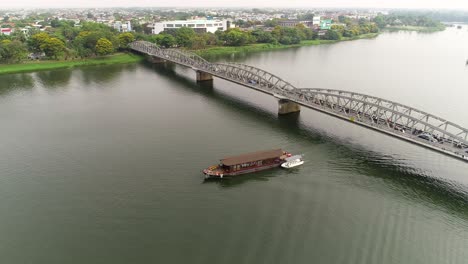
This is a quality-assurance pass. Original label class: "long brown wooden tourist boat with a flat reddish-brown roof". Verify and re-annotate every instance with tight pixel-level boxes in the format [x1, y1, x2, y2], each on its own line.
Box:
[203, 149, 291, 178]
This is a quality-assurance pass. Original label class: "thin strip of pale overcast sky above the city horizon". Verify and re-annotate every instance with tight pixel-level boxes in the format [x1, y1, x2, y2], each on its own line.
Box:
[0, 0, 468, 10]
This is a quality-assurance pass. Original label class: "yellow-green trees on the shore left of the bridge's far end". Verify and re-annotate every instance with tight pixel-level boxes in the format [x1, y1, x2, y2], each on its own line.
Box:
[0, 20, 135, 63]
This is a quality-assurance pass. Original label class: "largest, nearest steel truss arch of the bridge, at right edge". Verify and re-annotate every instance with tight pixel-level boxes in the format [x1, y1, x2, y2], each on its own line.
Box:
[290, 88, 468, 148]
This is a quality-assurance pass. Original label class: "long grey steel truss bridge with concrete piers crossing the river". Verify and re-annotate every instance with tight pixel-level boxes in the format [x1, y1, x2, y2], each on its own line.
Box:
[129, 41, 468, 162]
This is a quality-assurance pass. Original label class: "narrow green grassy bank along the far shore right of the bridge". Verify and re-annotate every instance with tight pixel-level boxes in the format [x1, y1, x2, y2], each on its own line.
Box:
[193, 33, 378, 57]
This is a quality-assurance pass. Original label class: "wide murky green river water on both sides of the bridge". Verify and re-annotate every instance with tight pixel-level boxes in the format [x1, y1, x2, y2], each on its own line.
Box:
[0, 26, 468, 264]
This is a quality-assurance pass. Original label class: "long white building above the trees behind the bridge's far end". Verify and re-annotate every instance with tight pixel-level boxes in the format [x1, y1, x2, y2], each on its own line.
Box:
[152, 20, 230, 34]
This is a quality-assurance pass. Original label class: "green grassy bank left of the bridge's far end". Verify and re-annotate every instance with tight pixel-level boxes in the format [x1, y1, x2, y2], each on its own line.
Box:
[0, 53, 144, 74]
